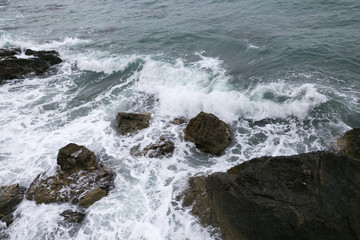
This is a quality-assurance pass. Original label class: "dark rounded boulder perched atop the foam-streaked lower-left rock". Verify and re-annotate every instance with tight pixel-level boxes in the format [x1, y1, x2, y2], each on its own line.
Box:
[57, 143, 99, 171]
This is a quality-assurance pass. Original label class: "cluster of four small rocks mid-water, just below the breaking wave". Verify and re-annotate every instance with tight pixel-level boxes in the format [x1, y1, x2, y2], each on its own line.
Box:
[116, 112, 232, 157]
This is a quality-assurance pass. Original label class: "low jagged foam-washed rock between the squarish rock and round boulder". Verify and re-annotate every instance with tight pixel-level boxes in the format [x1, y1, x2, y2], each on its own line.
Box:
[130, 137, 175, 158]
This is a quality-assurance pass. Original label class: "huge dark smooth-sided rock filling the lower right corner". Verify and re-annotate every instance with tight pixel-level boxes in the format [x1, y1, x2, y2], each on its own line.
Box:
[182, 152, 360, 240]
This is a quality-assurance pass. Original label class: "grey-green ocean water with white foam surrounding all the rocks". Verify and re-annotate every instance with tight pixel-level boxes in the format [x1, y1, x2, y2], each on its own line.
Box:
[0, 0, 360, 240]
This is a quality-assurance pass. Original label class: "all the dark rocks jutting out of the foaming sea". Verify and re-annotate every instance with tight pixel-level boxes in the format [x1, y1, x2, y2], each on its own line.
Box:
[0, 49, 360, 240]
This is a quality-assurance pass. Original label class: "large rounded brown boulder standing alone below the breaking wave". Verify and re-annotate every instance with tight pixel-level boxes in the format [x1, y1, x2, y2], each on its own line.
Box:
[184, 112, 232, 155]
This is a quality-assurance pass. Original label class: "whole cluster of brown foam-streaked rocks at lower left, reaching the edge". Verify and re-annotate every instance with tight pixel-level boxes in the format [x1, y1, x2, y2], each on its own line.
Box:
[0, 143, 115, 226]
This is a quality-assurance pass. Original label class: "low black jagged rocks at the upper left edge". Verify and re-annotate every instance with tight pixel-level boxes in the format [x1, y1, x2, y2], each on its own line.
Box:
[0, 48, 62, 83]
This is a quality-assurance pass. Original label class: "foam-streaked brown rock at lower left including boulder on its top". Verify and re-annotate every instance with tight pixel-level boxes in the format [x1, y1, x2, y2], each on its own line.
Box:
[26, 144, 115, 207]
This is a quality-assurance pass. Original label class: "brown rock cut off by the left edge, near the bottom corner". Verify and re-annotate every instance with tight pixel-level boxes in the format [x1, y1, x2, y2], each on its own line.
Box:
[0, 184, 26, 226]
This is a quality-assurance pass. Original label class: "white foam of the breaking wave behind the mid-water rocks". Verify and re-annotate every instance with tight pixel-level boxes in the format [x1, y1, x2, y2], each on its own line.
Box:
[135, 53, 327, 122]
